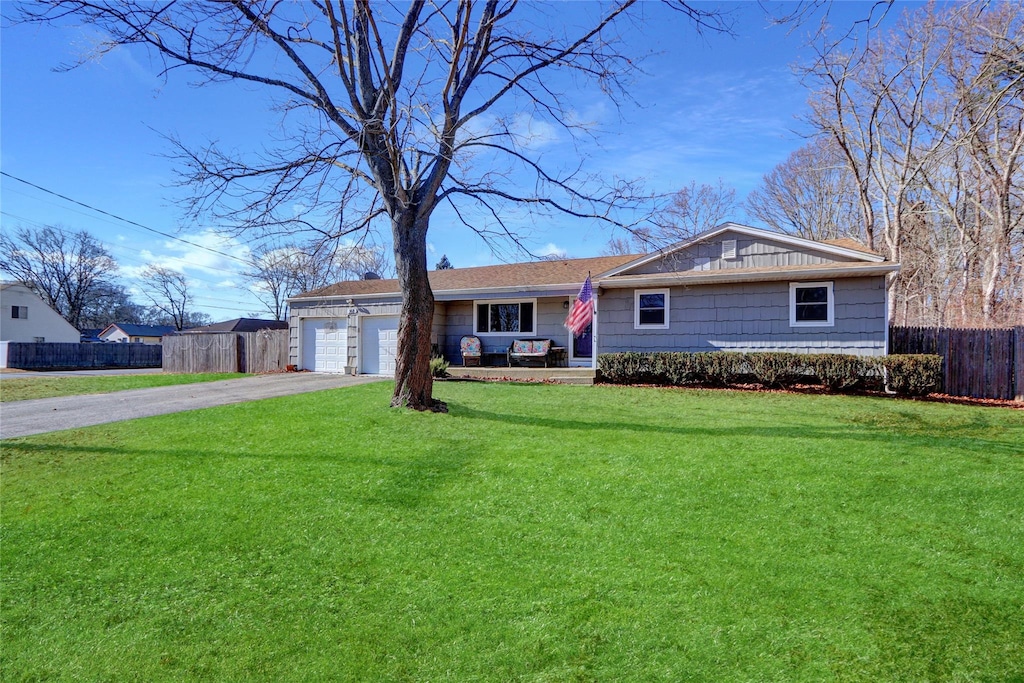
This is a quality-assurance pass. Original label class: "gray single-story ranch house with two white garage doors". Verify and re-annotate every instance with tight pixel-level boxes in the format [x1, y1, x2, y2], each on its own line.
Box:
[289, 223, 899, 374]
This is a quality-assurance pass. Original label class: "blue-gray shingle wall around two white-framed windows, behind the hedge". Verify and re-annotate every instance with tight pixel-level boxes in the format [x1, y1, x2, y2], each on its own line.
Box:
[598, 278, 886, 355]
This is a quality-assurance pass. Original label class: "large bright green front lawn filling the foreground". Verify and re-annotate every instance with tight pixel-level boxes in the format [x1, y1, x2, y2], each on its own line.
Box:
[0, 383, 1024, 681]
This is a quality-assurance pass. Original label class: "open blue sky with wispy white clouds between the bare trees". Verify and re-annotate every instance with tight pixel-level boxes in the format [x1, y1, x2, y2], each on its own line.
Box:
[0, 2, 897, 319]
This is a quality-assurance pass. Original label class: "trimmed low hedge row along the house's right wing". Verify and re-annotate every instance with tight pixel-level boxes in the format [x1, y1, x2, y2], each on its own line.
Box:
[598, 351, 942, 395]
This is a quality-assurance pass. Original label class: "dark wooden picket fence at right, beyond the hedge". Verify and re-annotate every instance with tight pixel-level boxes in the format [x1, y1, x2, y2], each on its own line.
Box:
[889, 327, 1024, 400]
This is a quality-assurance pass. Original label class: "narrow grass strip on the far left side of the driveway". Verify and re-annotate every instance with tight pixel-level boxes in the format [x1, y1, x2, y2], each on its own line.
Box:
[0, 373, 246, 401]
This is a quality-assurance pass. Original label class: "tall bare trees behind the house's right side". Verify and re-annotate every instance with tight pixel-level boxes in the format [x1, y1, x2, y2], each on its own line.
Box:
[607, 2, 1024, 327]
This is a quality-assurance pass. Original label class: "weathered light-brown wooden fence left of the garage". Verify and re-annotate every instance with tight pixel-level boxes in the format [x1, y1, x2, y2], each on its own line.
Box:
[164, 330, 288, 373]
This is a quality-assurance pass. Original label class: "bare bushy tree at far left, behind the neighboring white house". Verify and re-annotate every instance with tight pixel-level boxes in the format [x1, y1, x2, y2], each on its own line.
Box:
[0, 226, 118, 328]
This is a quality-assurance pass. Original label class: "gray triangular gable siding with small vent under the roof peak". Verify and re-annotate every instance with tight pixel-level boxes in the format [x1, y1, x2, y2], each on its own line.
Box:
[630, 231, 854, 274]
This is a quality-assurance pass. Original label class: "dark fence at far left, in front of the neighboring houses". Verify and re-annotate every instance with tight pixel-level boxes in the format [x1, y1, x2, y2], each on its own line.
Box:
[3, 342, 161, 370]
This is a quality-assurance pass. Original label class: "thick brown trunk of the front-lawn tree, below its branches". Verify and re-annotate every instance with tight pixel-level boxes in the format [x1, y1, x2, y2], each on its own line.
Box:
[391, 209, 447, 413]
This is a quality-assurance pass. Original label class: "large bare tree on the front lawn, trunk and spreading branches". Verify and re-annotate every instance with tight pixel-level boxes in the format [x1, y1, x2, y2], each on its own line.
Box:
[22, 0, 737, 410]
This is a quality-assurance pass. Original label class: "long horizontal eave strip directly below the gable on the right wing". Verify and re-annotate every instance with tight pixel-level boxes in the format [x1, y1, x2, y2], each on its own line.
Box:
[596, 263, 899, 290]
